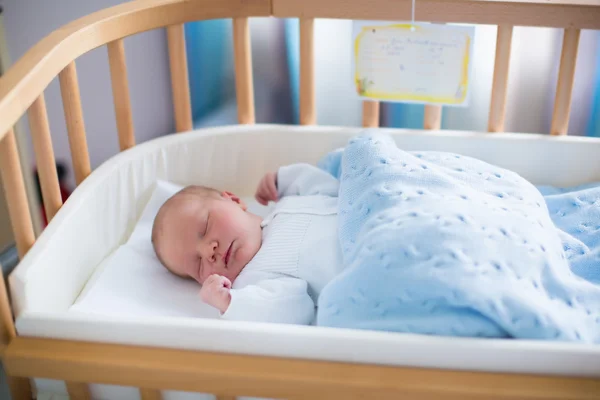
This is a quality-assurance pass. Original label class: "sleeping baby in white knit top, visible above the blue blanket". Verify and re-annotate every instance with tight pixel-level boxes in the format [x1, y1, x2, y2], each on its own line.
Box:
[152, 164, 342, 324]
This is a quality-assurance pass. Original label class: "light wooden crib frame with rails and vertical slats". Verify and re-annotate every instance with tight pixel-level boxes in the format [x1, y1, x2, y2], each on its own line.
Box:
[0, 0, 600, 400]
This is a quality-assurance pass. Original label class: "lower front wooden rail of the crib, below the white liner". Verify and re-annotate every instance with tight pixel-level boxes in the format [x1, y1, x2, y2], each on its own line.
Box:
[5, 337, 600, 400]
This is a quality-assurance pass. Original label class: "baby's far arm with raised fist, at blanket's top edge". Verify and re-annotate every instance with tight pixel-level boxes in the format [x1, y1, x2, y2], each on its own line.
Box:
[256, 163, 340, 205]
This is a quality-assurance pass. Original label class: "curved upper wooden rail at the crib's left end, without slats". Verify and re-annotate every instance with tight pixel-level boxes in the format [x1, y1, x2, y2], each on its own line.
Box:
[0, 0, 271, 138]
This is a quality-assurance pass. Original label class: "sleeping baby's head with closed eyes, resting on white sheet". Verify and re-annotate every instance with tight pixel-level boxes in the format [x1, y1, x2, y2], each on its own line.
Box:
[158, 193, 262, 284]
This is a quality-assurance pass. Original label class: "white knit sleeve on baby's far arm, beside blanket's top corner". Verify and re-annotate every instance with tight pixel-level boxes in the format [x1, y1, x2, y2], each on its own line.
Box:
[277, 163, 340, 198]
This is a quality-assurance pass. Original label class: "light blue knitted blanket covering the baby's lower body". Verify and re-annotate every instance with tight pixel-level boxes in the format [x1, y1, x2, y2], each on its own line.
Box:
[317, 131, 600, 343]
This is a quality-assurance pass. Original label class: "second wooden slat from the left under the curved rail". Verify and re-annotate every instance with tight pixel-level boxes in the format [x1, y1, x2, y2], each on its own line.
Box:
[28, 93, 62, 222]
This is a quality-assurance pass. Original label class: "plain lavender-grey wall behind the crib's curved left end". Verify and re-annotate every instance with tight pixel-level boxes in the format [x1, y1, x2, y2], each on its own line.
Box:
[0, 0, 174, 188]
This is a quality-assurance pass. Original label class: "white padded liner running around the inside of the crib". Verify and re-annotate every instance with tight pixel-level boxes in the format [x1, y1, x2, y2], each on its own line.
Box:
[10, 125, 600, 396]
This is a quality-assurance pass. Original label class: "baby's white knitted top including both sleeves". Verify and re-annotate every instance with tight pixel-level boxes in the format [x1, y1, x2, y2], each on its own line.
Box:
[222, 164, 343, 325]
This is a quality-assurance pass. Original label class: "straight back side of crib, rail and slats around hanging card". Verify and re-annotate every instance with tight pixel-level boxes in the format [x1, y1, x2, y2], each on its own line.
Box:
[272, 0, 600, 135]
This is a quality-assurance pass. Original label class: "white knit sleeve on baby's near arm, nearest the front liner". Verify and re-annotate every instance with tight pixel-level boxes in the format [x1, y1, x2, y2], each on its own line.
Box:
[221, 276, 315, 325]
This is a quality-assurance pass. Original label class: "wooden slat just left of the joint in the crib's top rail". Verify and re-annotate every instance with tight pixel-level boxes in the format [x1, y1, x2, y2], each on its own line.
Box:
[233, 18, 255, 124]
